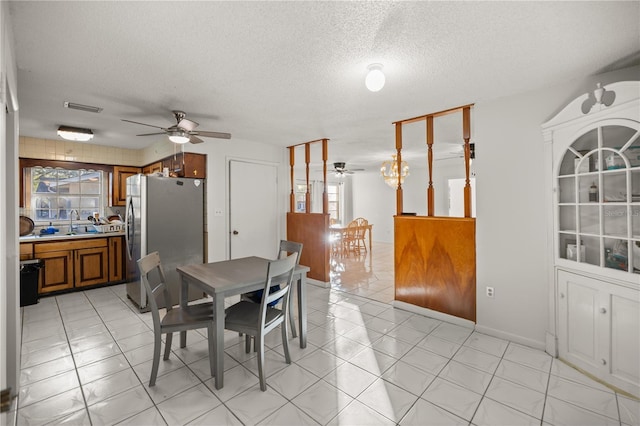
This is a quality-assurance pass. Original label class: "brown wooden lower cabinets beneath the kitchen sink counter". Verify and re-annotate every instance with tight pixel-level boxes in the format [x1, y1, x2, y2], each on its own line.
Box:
[29, 236, 124, 294]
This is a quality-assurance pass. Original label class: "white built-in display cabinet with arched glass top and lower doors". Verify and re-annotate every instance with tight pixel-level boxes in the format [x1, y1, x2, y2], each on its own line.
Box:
[542, 81, 640, 396]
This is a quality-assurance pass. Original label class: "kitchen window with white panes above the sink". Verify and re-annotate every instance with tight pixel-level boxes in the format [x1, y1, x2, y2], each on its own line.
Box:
[23, 167, 108, 223]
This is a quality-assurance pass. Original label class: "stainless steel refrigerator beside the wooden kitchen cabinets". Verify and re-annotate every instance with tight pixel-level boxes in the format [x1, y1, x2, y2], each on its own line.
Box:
[125, 174, 205, 312]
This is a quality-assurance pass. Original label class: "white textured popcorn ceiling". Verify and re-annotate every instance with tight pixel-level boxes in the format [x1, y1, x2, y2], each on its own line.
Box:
[10, 1, 640, 167]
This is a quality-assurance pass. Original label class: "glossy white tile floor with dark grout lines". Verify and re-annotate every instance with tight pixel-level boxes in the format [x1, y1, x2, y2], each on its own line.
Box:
[17, 244, 640, 426]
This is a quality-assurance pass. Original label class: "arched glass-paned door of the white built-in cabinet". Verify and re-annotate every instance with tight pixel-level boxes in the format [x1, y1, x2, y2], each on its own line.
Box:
[557, 125, 640, 274]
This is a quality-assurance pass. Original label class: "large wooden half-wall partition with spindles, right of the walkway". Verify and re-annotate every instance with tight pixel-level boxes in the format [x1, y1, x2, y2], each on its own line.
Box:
[393, 105, 476, 322]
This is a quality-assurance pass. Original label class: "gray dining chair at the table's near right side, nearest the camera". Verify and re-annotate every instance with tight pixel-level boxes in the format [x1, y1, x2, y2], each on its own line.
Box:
[224, 253, 298, 391]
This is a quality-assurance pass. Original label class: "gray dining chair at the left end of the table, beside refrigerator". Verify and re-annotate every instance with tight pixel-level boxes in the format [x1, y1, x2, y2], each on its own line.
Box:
[138, 251, 215, 387]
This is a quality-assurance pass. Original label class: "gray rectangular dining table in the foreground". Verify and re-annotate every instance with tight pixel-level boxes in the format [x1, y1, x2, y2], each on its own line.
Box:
[176, 256, 310, 389]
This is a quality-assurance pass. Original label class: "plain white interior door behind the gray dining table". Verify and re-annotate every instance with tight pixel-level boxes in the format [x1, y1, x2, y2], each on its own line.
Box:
[228, 160, 279, 259]
